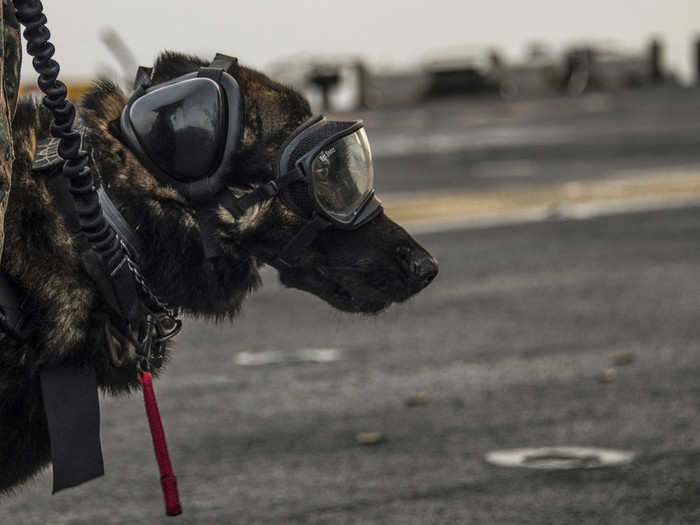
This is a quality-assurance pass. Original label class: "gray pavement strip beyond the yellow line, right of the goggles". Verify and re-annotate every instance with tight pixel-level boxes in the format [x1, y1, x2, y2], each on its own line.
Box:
[360, 89, 700, 192]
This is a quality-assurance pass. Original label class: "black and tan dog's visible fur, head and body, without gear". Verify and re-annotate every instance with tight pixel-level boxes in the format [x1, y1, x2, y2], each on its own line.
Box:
[0, 52, 438, 493]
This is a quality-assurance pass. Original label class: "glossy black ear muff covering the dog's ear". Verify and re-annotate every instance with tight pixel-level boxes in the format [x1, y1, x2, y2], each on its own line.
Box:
[120, 54, 242, 202]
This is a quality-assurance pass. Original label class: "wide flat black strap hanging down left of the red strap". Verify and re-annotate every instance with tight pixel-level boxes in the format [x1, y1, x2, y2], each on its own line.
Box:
[39, 365, 104, 493]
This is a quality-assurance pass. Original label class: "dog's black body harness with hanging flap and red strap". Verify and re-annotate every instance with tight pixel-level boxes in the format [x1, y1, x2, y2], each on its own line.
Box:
[0, 115, 182, 512]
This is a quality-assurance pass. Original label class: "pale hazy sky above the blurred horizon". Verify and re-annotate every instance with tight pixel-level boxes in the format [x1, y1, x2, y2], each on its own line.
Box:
[24, 0, 700, 81]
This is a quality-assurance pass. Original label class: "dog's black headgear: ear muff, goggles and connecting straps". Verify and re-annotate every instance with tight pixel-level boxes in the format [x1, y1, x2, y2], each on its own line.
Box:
[120, 54, 381, 268]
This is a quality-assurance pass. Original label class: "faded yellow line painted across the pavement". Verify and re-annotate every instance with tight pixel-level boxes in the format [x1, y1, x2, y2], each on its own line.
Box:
[383, 169, 700, 227]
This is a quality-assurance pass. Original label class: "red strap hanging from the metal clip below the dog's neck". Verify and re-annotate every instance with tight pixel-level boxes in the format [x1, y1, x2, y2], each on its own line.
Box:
[138, 371, 182, 516]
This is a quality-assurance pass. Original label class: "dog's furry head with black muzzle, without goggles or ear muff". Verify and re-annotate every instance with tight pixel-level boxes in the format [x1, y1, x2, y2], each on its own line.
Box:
[83, 53, 438, 315]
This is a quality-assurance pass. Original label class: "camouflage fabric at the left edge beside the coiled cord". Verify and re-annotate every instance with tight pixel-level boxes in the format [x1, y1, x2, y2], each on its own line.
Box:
[0, 0, 22, 262]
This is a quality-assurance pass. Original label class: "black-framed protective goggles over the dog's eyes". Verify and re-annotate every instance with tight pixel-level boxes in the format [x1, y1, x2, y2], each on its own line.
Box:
[277, 116, 381, 229]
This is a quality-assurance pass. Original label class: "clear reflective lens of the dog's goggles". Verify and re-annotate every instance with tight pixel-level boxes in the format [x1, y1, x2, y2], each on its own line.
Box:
[311, 129, 374, 222]
